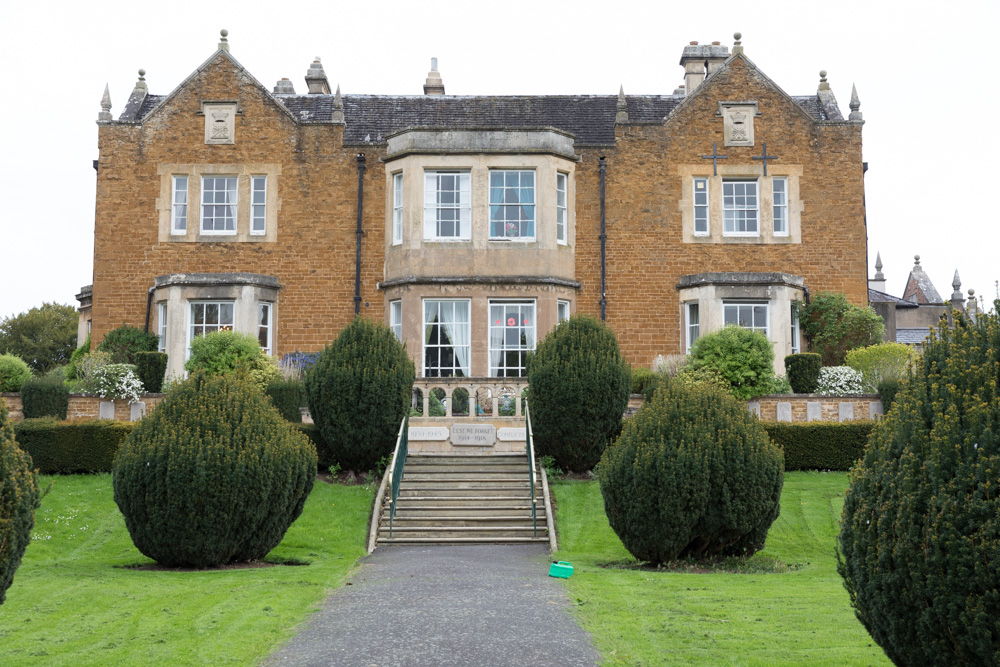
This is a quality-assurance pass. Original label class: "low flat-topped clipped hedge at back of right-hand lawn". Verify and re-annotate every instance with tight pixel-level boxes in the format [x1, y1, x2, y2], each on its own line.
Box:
[761, 420, 875, 470]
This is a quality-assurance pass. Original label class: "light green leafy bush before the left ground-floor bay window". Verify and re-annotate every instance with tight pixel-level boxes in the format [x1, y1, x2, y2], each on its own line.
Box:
[184, 331, 280, 392]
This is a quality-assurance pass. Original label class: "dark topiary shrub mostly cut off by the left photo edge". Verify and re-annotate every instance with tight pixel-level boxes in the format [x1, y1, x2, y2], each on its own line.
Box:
[0, 398, 39, 604]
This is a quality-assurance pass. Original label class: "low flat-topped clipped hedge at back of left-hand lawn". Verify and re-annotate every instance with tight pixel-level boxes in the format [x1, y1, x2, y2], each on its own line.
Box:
[14, 418, 133, 475]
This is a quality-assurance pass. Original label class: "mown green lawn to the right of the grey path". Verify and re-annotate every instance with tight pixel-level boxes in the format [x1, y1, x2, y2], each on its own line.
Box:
[553, 472, 891, 667]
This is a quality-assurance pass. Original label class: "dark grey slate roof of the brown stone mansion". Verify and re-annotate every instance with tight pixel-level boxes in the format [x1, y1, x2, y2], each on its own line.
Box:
[118, 89, 830, 146]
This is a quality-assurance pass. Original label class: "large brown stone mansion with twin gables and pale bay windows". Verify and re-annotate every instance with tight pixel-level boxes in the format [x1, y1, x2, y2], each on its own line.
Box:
[81, 31, 867, 378]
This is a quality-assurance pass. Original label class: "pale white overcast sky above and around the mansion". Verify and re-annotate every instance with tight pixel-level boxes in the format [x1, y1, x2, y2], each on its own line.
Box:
[0, 0, 1000, 317]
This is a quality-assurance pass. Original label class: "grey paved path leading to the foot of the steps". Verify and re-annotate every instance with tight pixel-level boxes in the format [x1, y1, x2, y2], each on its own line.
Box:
[264, 545, 599, 667]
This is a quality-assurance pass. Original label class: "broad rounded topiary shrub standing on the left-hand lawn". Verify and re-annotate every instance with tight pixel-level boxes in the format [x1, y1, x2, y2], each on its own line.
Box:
[113, 374, 316, 567]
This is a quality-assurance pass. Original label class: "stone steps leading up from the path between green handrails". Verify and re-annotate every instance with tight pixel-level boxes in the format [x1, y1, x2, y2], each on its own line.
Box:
[377, 453, 549, 544]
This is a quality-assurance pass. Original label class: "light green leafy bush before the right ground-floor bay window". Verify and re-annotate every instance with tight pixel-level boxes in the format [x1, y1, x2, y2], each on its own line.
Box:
[689, 325, 774, 400]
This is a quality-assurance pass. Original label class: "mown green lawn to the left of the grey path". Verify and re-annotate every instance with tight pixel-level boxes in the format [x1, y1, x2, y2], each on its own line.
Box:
[0, 475, 374, 666]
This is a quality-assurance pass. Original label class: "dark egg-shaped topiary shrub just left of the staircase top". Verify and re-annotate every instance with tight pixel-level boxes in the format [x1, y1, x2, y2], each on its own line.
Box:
[306, 317, 416, 471]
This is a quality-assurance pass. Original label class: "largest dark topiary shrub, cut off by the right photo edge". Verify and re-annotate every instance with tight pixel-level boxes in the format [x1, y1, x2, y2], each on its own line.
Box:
[839, 310, 1000, 666]
